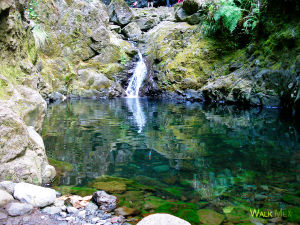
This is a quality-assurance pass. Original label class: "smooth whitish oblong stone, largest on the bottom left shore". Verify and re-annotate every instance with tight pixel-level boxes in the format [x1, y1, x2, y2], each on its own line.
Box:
[14, 183, 56, 207]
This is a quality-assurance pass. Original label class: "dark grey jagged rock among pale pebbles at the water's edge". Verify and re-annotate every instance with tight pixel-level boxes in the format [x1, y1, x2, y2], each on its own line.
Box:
[93, 191, 117, 211]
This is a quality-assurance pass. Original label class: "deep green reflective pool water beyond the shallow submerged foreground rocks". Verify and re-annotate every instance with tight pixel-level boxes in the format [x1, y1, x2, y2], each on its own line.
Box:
[42, 98, 300, 206]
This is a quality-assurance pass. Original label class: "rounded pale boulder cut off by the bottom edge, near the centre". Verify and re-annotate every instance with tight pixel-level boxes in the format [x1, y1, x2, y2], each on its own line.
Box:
[137, 213, 191, 225]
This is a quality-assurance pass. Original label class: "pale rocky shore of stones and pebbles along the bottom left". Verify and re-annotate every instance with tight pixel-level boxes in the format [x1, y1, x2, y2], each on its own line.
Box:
[0, 181, 196, 225]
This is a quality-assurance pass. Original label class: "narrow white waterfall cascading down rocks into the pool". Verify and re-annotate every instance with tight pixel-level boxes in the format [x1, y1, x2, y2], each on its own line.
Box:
[126, 51, 147, 98]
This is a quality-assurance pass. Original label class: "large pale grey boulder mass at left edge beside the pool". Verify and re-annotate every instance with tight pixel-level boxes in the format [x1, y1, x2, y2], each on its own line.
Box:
[0, 89, 55, 184]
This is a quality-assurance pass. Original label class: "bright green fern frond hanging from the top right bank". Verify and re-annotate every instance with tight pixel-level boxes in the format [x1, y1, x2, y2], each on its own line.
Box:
[214, 0, 242, 33]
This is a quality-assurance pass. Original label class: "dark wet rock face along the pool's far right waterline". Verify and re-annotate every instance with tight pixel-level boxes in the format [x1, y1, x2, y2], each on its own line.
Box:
[201, 69, 299, 108]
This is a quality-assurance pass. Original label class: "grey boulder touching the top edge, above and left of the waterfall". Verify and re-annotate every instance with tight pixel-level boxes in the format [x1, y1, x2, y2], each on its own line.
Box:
[108, 0, 133, 26]
